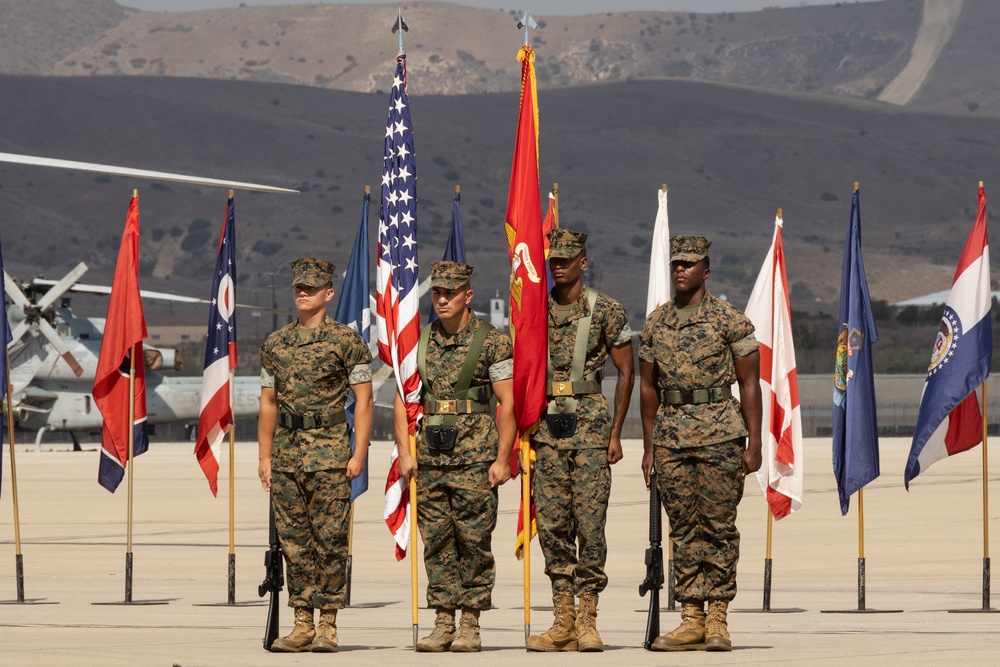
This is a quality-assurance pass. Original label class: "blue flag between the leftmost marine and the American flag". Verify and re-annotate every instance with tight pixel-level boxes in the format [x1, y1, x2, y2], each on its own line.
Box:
[334, 192, 371, 503]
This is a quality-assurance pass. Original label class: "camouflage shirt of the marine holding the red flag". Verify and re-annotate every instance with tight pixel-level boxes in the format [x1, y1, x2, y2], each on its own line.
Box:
[532, 285, 632, 450]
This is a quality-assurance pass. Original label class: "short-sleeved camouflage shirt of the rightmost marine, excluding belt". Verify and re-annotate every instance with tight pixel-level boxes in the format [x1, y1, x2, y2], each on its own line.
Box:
[639, 294, 758, 447]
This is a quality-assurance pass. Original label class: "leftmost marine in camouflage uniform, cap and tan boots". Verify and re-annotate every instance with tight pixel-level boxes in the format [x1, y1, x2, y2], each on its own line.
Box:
[257, 259, 372, 652]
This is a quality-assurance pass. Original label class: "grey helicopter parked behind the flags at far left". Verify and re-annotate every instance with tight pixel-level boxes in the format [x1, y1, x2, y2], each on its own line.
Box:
[4, 262, 260, 449]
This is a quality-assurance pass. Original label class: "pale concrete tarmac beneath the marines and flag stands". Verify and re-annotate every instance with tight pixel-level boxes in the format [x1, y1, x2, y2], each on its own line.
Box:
[0, 438, 1000, 667]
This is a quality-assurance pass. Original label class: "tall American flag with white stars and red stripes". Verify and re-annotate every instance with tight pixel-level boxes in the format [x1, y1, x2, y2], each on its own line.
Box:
[376, 53, 423, 560]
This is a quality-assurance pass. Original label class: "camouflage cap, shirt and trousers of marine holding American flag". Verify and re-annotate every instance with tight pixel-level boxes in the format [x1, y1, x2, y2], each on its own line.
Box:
[417, 262, 513, 611]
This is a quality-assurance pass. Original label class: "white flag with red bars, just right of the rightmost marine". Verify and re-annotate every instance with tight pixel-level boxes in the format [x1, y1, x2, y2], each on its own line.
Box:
[746, 211, 802, 519]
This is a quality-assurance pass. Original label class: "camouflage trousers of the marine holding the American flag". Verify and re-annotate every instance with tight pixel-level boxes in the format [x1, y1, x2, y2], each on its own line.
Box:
[417, 463, 497, 610]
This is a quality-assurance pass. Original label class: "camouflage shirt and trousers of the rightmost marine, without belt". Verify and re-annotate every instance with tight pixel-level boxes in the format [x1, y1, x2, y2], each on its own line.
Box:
[639, 282, 757, 604]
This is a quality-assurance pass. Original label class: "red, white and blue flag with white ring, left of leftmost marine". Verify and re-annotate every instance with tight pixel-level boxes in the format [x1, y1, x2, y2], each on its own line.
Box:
[194, 197, 236, 496]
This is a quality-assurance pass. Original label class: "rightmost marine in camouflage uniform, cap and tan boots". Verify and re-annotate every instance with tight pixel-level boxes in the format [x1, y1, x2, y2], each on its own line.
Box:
[639, 236, 761, 651]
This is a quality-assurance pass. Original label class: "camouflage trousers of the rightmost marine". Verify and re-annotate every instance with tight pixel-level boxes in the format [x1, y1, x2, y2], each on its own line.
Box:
[654, 438, 745, 602]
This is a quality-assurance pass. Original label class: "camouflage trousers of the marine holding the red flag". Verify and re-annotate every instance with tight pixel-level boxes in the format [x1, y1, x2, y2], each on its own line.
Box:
[532, 444, 611, 597]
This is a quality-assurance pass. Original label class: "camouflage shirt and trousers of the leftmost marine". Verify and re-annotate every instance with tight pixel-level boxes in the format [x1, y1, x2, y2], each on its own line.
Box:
[260, 260, 372, 610]
